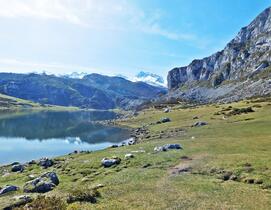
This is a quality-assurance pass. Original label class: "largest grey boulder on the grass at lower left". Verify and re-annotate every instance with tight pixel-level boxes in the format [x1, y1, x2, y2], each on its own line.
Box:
[24, 172, 59, 193]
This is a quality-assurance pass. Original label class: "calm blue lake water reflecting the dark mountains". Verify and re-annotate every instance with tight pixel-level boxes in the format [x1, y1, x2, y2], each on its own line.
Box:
[0, 111, 129, 164]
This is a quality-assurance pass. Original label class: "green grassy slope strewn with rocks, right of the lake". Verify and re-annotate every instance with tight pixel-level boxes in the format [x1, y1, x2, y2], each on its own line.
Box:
[0, 99, 271, 210]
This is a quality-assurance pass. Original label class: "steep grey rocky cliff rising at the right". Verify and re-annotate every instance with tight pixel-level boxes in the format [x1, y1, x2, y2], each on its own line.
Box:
[167, 8, 271, 102]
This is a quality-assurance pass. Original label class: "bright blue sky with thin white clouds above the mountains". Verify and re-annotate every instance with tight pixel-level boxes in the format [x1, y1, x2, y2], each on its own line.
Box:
[0, 0, 271, 77]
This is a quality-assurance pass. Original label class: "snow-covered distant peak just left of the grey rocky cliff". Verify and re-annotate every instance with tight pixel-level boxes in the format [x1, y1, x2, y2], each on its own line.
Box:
[133, 71, 166, 87]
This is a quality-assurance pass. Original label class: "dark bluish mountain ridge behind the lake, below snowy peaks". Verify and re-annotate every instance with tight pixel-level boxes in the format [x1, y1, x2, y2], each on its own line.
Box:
[0, 73, 165, 109]
